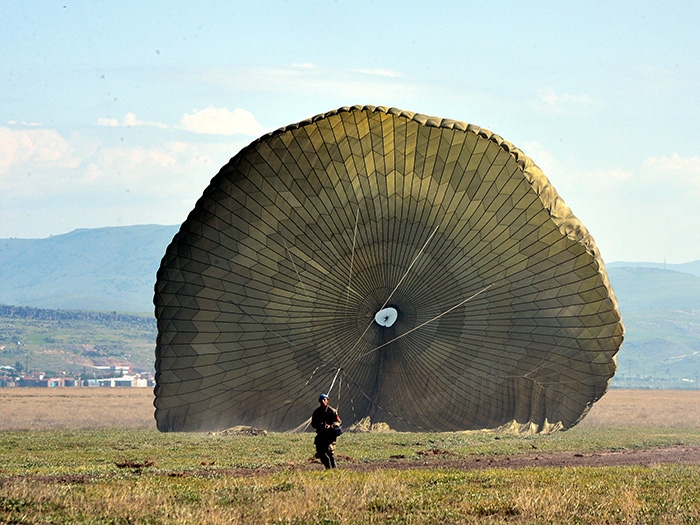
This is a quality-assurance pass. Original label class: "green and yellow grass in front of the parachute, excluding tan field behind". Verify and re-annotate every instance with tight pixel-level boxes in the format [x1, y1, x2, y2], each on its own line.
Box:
[0, 429, 700, 524]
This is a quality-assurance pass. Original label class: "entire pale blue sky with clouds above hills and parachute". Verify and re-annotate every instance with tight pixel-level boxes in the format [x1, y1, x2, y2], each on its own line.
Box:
[0, 0, 700, 263]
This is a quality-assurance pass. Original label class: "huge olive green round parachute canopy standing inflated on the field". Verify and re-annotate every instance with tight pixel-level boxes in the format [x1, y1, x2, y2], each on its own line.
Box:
[154, 106, 623, 432]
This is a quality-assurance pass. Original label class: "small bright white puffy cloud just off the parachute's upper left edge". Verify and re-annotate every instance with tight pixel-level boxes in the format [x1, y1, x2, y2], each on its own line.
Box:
[180, 106, 266, 137]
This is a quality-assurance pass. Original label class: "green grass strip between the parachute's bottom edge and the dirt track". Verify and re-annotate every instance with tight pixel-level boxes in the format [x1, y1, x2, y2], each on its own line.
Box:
[0, 427, 700, 476]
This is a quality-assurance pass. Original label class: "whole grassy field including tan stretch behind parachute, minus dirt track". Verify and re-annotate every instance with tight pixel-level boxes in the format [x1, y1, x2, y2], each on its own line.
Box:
[0, 389, 700, 524]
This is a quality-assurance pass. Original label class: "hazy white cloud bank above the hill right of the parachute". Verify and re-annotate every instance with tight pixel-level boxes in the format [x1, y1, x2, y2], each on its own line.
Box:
[526, 152, 700, 263]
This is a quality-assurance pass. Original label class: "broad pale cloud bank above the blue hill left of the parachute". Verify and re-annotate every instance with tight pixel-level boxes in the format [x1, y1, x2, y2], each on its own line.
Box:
[0, 127, 248, 238]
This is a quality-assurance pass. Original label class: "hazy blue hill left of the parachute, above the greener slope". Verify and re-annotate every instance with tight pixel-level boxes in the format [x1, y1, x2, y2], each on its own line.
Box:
[0, 225, 179, 312]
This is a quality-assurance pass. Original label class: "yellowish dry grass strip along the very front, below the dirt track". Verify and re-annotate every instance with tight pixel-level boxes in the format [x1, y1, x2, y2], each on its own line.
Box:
[0, 466, 700, 524]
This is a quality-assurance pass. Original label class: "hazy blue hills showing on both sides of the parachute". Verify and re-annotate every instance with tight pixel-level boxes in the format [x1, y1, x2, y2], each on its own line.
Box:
[0, 225, 700, 388]
